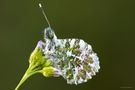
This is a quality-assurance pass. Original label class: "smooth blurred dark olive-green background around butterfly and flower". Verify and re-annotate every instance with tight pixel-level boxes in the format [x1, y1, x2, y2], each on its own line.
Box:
[0, 0, 135, 90]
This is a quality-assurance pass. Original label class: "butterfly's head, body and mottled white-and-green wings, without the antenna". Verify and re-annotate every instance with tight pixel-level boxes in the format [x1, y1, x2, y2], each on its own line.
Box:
[43, 28, 100, 84]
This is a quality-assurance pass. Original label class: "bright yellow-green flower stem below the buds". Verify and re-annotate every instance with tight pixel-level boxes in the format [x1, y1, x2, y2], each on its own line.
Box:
[15, 66, 39, 90]
